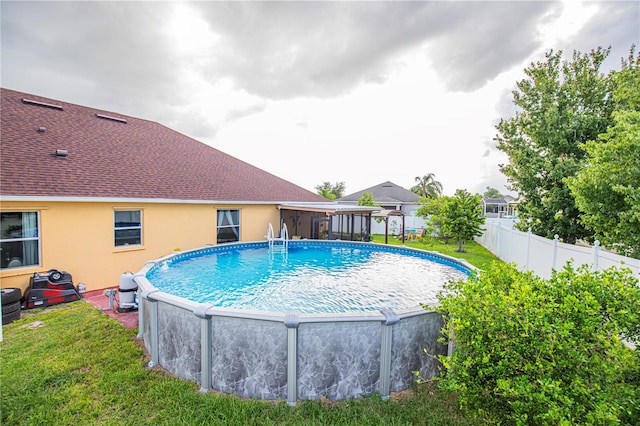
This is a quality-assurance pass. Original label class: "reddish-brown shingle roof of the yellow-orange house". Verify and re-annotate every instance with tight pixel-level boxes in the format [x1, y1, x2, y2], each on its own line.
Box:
[0, 89, 326, 202]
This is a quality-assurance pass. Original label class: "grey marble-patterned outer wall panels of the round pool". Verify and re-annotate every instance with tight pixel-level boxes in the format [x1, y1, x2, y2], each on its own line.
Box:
[141, 292, 447, 400]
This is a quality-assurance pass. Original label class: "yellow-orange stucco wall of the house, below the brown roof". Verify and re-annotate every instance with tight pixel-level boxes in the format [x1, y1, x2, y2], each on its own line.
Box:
[0, 201, 280, 290]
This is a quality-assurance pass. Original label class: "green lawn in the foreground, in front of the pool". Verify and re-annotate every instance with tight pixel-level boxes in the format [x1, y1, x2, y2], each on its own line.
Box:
[0, 301, 479, 425]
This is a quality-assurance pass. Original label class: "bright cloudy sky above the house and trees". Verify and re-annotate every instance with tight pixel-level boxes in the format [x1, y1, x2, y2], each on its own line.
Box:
[0, 0, 640, 194]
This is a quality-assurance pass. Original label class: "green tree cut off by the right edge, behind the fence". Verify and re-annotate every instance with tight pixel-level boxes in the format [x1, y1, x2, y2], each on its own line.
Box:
[567, 50, 640, 258]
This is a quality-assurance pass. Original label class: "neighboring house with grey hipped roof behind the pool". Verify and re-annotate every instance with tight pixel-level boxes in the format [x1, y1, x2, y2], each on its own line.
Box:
[336, 181, 424, 234]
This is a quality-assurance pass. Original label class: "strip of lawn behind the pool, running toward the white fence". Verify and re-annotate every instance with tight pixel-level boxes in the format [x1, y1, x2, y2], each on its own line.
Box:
[371, 235, 501, 269]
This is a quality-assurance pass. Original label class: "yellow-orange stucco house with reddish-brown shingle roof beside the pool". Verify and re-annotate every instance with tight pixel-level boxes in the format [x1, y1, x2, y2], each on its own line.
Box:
[0, 89, 375, 290]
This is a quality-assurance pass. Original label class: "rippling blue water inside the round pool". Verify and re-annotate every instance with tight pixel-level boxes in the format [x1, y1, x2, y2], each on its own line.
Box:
[146, 242, 469, 314]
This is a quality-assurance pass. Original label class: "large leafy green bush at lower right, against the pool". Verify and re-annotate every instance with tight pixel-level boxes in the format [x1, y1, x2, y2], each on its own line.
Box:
[438, 262, 640, 425]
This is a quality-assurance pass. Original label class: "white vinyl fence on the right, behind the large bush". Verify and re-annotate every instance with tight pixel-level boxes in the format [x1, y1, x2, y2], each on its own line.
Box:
[475, 219, 640, 278]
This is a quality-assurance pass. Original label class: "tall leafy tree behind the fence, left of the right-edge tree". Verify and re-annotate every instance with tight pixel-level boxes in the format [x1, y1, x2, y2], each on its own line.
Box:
[495, 48, 613, 243]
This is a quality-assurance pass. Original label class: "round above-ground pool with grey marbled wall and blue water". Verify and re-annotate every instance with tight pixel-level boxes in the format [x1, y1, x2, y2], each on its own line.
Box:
[134, 240, 472, 405]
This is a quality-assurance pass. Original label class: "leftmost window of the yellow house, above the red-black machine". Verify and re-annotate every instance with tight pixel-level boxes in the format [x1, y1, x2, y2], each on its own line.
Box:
[0, 212, 40, 269]
